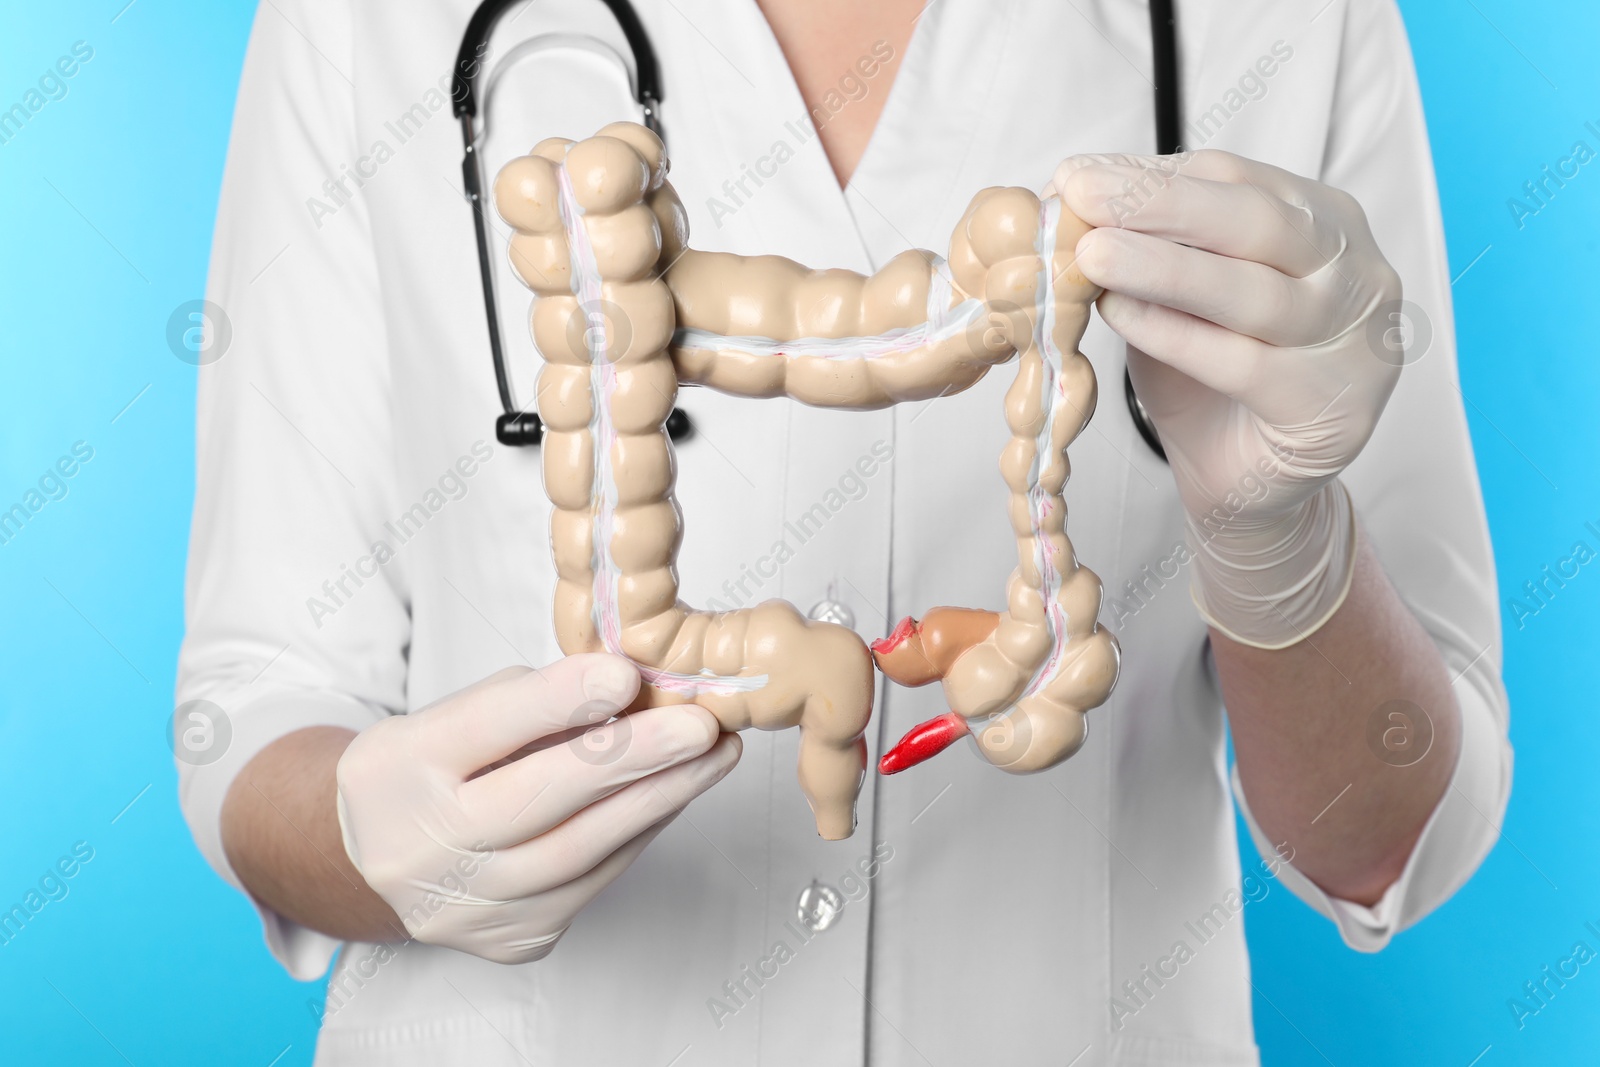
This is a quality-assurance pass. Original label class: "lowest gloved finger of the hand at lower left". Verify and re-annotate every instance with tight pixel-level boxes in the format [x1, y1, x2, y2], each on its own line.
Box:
[474, 734, 742, 901]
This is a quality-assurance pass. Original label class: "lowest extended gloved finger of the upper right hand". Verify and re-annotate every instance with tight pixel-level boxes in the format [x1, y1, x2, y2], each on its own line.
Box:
[1096, 291, 1270, 405]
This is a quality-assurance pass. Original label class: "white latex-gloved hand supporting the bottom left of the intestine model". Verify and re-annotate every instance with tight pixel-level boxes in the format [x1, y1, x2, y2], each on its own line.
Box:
[338, 654, 741, 963]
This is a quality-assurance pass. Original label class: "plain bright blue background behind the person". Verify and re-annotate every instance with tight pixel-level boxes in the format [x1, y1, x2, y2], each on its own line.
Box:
[0, 0, 1600, 1067]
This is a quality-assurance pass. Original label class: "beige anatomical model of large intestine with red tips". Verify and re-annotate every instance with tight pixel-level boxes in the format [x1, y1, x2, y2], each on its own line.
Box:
[494, 123, 1118, 840]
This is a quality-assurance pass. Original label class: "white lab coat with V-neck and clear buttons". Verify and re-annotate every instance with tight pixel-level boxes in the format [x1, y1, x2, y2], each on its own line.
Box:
[178, 0, 1510, 1067]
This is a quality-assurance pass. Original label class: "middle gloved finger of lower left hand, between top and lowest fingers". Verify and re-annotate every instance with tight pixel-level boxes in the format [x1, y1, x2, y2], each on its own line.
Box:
[456, 704, 720, 848]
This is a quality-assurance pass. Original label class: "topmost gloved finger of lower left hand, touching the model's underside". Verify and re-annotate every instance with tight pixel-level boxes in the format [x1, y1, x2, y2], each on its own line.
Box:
[418, 653, 638, 779]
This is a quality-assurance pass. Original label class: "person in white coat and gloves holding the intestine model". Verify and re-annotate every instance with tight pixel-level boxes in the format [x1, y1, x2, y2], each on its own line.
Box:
[178, 0, 1510, 1067]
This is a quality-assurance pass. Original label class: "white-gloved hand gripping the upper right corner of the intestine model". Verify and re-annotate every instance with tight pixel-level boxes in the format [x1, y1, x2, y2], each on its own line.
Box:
[1051, 150, 1405, 648]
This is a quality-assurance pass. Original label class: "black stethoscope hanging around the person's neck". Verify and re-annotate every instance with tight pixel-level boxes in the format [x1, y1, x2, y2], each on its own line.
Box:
[451, 0, 1182, 459]
